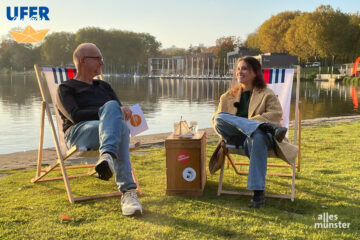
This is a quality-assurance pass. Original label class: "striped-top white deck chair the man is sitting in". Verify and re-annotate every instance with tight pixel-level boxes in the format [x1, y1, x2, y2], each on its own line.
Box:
[31, 64, 141, 203]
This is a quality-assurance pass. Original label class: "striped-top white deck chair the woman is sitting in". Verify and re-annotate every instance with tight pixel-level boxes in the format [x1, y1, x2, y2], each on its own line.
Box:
[217, 66, 301, 202]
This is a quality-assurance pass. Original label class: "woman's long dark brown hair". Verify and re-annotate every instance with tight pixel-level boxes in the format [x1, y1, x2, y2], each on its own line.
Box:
[230, 56, 266, 93]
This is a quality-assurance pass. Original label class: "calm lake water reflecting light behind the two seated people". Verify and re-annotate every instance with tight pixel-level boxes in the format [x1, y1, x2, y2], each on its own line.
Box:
[0, 75, 360, 154]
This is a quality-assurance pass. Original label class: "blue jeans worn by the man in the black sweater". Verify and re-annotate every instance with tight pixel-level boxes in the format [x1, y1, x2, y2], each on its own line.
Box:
[65, 100, 136, 192]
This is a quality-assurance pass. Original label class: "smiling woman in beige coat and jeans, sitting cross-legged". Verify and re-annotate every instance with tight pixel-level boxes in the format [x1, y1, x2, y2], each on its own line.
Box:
[212, 57, 297, 208]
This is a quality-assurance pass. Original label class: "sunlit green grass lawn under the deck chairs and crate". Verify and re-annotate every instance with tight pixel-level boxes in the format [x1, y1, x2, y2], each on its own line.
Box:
[0, 121, 360, 239]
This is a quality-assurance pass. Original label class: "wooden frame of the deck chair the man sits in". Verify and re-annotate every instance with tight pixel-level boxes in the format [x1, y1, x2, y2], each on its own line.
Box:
[31, 64, 141, 203]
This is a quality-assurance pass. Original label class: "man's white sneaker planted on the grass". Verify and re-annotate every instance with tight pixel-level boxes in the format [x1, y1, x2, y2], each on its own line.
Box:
[121, 189, 142, 216]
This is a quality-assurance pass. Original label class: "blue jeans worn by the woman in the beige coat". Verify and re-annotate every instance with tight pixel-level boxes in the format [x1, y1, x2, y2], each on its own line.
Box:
[214, 112, 274, 190]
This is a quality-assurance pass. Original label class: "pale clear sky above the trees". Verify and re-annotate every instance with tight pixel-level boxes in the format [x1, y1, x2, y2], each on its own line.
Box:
[0, 0, 360, 48]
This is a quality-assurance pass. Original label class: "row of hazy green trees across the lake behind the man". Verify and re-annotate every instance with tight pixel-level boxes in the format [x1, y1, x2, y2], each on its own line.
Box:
[0, 27, 161, 72]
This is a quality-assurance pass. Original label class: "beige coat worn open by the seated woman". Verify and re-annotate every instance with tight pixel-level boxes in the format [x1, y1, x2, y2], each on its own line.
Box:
[212, 88, 298, 164]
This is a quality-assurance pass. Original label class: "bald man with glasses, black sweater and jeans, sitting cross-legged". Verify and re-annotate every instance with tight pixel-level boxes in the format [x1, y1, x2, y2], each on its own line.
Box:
[57, 43, 142, 215]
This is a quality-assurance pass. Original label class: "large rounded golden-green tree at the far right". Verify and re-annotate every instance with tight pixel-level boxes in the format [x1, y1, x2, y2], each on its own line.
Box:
[285, 5, 359, 60]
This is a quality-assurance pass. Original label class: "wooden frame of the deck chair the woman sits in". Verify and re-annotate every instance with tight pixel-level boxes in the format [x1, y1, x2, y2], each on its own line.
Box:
[217, 66, 301, 202]
